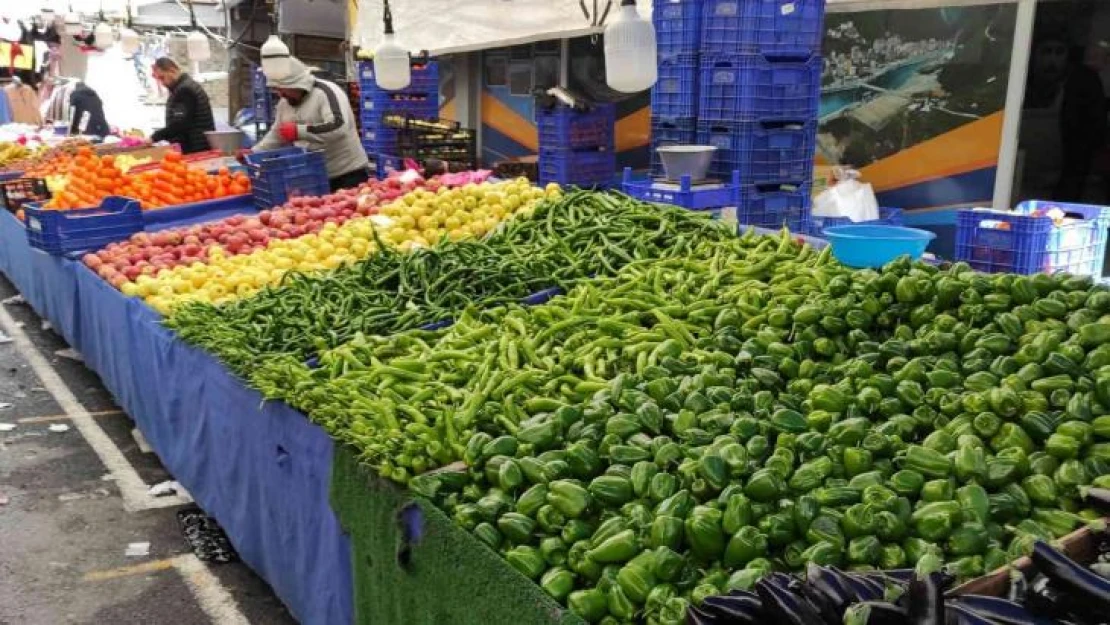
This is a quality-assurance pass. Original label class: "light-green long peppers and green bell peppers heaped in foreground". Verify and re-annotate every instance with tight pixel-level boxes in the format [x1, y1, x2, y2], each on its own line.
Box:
[202, 208, 1110, 623]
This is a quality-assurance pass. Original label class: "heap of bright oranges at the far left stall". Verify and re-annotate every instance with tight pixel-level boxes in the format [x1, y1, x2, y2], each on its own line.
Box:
[44, 148, 251, 210]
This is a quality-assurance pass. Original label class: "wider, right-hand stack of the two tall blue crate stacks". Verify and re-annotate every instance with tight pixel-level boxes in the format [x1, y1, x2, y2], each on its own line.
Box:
[692, 0, 825, 230]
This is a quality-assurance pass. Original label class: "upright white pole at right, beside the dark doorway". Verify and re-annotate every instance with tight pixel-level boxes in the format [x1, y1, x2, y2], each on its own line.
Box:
[992, 0, 1037, 210]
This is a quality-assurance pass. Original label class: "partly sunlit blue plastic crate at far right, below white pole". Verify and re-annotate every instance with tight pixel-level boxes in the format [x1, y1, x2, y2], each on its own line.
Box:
[956, 201, 1110, 276]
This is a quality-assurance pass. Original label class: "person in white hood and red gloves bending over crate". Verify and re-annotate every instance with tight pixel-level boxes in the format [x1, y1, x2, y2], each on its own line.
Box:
[253, 59, 370, 192]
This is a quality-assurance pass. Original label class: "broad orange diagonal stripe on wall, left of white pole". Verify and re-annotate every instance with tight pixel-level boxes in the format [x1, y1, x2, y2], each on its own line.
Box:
[860, 111, 1002, 191]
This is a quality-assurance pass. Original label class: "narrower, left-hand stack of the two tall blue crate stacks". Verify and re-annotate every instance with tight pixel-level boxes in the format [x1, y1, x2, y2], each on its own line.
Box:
[652, 0, 705, 175]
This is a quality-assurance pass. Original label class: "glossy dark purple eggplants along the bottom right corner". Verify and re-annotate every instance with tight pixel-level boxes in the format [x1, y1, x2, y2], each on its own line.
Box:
[686, 537, 1110, 625]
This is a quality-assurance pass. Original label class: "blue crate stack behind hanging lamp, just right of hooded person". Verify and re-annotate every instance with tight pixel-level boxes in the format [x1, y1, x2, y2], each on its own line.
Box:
[359, 61, 440, 160]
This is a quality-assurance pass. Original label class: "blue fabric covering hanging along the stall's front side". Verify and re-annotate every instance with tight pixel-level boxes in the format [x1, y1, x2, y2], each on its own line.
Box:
[0, 208, 353, 625]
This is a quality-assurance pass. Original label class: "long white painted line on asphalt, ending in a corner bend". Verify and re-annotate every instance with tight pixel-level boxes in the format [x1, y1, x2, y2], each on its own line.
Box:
[0, 306, 192, 512]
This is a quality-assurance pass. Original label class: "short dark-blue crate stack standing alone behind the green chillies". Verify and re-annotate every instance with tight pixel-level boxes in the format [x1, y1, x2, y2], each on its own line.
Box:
[536, 103, 617, 188]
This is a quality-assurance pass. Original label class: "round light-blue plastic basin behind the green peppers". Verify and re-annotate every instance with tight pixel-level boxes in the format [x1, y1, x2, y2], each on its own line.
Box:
[823, 225, 937, 268]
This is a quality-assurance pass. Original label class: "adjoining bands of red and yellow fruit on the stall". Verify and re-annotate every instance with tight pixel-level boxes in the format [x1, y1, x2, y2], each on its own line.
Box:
[103, 178, 550, 314]
